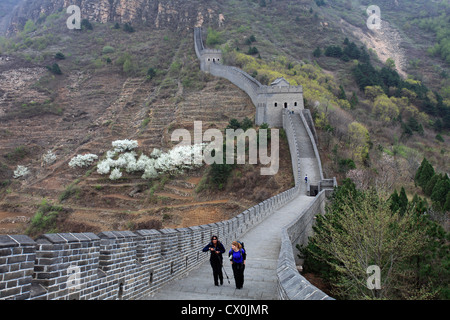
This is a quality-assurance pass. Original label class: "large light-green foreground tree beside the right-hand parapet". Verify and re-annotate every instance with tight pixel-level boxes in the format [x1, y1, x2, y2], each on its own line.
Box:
[303, 183, 427, 299]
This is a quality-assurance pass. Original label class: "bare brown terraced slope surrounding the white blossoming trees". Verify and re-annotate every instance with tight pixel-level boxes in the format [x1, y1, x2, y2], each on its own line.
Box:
[0, 53, 292, 234]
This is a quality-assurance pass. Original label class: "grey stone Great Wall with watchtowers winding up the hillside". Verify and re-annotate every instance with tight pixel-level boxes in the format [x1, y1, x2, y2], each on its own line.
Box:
[0, 28, 336, 300]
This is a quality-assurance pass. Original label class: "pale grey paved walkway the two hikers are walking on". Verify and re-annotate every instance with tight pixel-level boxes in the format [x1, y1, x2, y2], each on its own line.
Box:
[143, 196, 314, 300]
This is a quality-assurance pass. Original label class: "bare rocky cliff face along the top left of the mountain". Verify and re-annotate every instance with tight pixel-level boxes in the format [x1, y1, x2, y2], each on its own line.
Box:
[8, 0, 222, 34]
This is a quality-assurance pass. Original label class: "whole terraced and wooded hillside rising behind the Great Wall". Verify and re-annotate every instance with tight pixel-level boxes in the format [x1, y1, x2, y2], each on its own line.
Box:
[0, 0, 450, 233]
